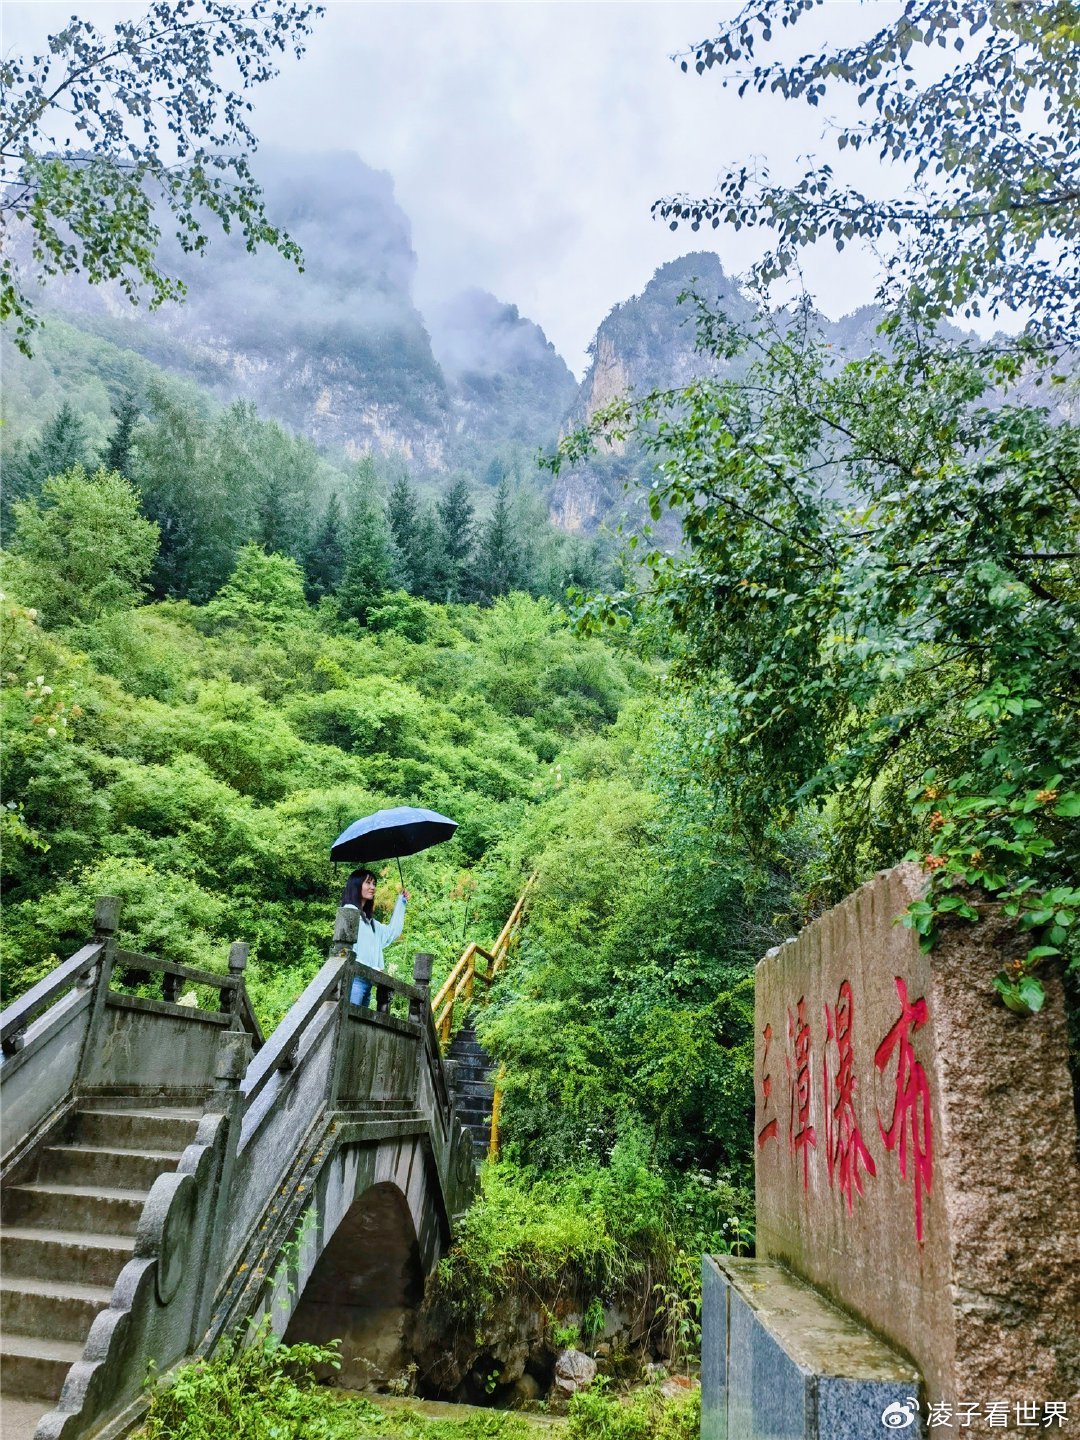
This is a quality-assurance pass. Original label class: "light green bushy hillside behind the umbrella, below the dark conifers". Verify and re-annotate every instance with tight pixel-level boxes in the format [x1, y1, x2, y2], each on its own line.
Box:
[0, 570, 650, 1024]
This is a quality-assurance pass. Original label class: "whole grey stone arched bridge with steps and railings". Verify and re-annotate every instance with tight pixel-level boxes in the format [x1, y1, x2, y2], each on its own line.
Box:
[0, 897, 489, 1440]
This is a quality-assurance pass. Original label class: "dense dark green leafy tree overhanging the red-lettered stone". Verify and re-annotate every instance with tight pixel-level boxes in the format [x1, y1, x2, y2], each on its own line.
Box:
[567, 314, 1080, 1008]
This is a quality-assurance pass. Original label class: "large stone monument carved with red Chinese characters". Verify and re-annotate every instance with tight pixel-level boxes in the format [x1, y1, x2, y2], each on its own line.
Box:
[755, 865, 1080, 1405]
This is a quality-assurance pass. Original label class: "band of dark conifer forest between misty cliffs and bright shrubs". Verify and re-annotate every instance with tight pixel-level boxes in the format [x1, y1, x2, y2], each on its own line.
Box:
[0, 320, 609, 619]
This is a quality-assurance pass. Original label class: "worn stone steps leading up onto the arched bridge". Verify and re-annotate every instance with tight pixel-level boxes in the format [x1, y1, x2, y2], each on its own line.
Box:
[0, 1102, 202, 1440]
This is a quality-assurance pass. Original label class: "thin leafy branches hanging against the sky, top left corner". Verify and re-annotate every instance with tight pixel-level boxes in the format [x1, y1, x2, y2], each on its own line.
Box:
[0, 0, 315, 354]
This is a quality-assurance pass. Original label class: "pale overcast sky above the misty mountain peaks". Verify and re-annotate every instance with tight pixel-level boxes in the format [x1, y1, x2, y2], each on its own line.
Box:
[3, 0, 899, 374]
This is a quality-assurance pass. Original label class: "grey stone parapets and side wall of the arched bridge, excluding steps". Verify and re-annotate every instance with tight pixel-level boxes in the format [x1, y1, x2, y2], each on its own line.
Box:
[0, 899, 475, 1440]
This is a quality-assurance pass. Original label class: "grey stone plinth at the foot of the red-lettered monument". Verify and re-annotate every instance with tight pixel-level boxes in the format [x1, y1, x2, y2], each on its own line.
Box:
[705, 1256, 923, 1440]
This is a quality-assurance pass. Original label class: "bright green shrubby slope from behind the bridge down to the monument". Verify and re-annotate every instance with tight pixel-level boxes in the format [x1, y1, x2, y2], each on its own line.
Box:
[0, 457, 812, 1382]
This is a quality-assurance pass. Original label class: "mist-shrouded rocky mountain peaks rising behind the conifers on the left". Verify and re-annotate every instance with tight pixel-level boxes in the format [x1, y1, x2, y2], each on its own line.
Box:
[6, 151, 575, 474]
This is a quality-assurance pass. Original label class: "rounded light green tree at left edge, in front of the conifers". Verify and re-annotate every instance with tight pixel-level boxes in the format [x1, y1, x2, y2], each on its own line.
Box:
[12, 465, 158, 625]
